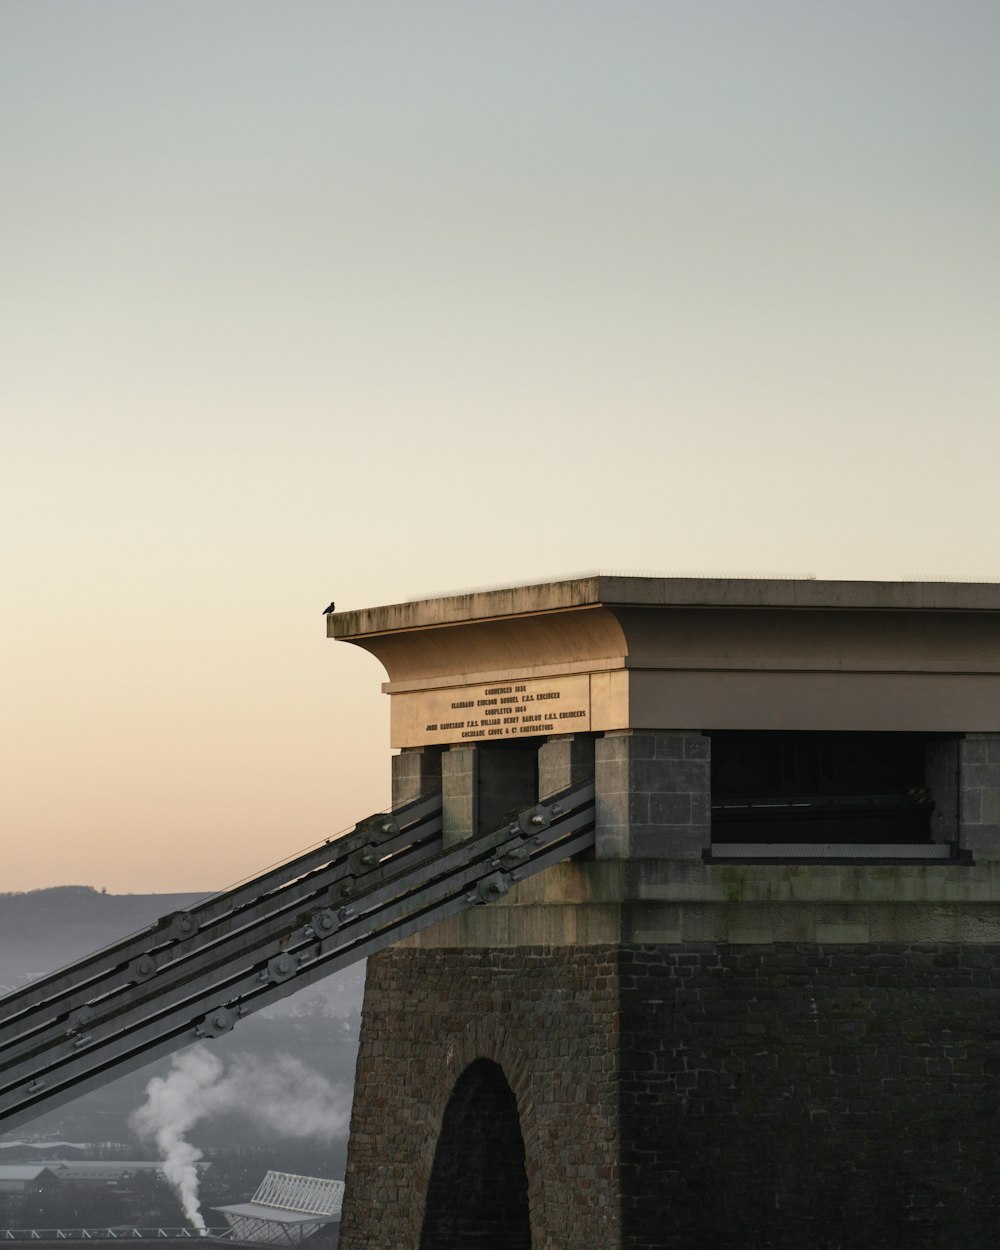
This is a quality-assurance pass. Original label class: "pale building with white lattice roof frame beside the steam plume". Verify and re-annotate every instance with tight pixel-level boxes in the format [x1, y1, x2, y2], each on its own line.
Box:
[215, 1171, 344, 1246]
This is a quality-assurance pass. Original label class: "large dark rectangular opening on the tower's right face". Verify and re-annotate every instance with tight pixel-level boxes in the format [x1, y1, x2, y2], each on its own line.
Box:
[711, 730, 946, 844]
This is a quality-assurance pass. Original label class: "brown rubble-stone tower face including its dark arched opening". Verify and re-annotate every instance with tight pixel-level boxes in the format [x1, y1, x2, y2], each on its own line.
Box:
[340, 946, 621, 1250]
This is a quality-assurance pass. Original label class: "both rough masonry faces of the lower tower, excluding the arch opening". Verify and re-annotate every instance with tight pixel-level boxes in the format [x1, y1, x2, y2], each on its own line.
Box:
[341, 943, 1000, 1250]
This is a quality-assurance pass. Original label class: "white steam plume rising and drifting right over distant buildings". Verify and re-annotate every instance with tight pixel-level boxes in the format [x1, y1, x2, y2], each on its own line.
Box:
[130, 1045, 350, 1233]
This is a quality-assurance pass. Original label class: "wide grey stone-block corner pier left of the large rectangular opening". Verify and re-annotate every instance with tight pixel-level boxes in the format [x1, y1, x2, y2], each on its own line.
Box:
[594, 729, 711, 860]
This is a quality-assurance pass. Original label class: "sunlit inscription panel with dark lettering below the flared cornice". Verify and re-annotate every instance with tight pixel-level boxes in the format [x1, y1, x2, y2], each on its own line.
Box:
[393, 674, 590, 746]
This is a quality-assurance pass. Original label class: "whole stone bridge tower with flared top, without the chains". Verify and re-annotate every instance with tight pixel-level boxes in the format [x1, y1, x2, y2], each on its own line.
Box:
[329, 576, 1000, 1250]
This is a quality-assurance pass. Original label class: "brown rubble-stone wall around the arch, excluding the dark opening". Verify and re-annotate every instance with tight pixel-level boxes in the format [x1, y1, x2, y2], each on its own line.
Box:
[340, 946, 621, 1250]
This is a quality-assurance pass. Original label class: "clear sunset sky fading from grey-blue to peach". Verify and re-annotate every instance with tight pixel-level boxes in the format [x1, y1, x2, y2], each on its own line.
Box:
[0, 0, 1000, 893]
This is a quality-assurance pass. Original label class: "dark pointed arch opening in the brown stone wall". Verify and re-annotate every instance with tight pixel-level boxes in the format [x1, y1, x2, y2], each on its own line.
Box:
[420, 1059, 531, 1250]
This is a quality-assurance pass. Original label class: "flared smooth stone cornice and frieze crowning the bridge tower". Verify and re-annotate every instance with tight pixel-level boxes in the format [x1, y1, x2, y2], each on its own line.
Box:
[326, 576, 1000, 746]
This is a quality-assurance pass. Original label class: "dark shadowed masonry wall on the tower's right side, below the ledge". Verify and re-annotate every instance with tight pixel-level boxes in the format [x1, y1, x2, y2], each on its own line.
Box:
[620, 945, 1000, 1250]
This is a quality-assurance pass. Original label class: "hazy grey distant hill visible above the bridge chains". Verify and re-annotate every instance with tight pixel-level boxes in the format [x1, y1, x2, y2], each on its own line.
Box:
[0, 885, 208, 994]
